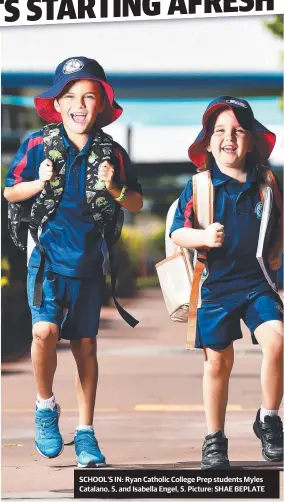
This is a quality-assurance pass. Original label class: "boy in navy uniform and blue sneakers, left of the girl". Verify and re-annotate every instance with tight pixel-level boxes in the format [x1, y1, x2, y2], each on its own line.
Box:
[4, 57, 142, 467]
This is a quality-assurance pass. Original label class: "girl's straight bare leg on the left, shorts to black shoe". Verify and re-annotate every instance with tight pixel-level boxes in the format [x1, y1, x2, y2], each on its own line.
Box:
[203, 344, 234, 434]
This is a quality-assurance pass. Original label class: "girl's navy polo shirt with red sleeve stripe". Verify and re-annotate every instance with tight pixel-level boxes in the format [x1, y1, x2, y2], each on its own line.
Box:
[170, 164, 276, 301]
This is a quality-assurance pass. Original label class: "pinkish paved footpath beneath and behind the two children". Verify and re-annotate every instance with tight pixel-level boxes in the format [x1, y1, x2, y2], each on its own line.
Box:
[2, 289, 281, 500]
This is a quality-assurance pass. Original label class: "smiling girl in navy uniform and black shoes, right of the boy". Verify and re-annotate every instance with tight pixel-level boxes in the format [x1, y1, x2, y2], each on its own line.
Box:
[171, 96, 283, 469]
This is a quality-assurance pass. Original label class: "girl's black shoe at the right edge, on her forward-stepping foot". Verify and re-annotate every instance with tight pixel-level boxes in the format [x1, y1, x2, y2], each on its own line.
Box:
[253, 410, 283, 462]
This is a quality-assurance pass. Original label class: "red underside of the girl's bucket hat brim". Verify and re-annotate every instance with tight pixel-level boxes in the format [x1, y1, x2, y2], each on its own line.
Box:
[188, 103, 276, 169]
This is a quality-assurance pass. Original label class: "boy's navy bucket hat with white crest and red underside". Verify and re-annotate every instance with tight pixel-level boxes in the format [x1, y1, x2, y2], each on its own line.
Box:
[34, 56, 123, 128]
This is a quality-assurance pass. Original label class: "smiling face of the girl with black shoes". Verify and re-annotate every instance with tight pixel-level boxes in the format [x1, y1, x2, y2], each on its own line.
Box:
[207, 110, 253, 170]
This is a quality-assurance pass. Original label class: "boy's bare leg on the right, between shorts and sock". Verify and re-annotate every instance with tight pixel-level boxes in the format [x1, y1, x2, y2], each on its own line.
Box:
[70, 337, 98, 425]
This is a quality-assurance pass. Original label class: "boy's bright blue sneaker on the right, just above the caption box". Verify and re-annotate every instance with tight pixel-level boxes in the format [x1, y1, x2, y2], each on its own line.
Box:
[74, 430, 106, 467]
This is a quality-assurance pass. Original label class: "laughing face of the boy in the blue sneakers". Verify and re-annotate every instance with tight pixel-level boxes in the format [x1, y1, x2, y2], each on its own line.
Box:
[54, 80, 104, 136]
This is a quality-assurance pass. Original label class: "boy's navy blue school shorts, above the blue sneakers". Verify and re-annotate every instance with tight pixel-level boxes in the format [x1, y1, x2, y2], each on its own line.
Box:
[27, 266, 105, 340]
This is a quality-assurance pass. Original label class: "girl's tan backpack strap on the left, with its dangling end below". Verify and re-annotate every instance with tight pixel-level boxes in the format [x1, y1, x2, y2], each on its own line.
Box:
[186, 171, 214, 350]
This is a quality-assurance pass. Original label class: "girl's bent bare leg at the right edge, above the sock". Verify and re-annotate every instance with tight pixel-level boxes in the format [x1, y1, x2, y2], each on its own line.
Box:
[254, 321, 283, 410]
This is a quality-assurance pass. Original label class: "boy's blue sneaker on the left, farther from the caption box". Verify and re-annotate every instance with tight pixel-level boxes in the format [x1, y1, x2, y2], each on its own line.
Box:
[35, 404, 64, 458]
